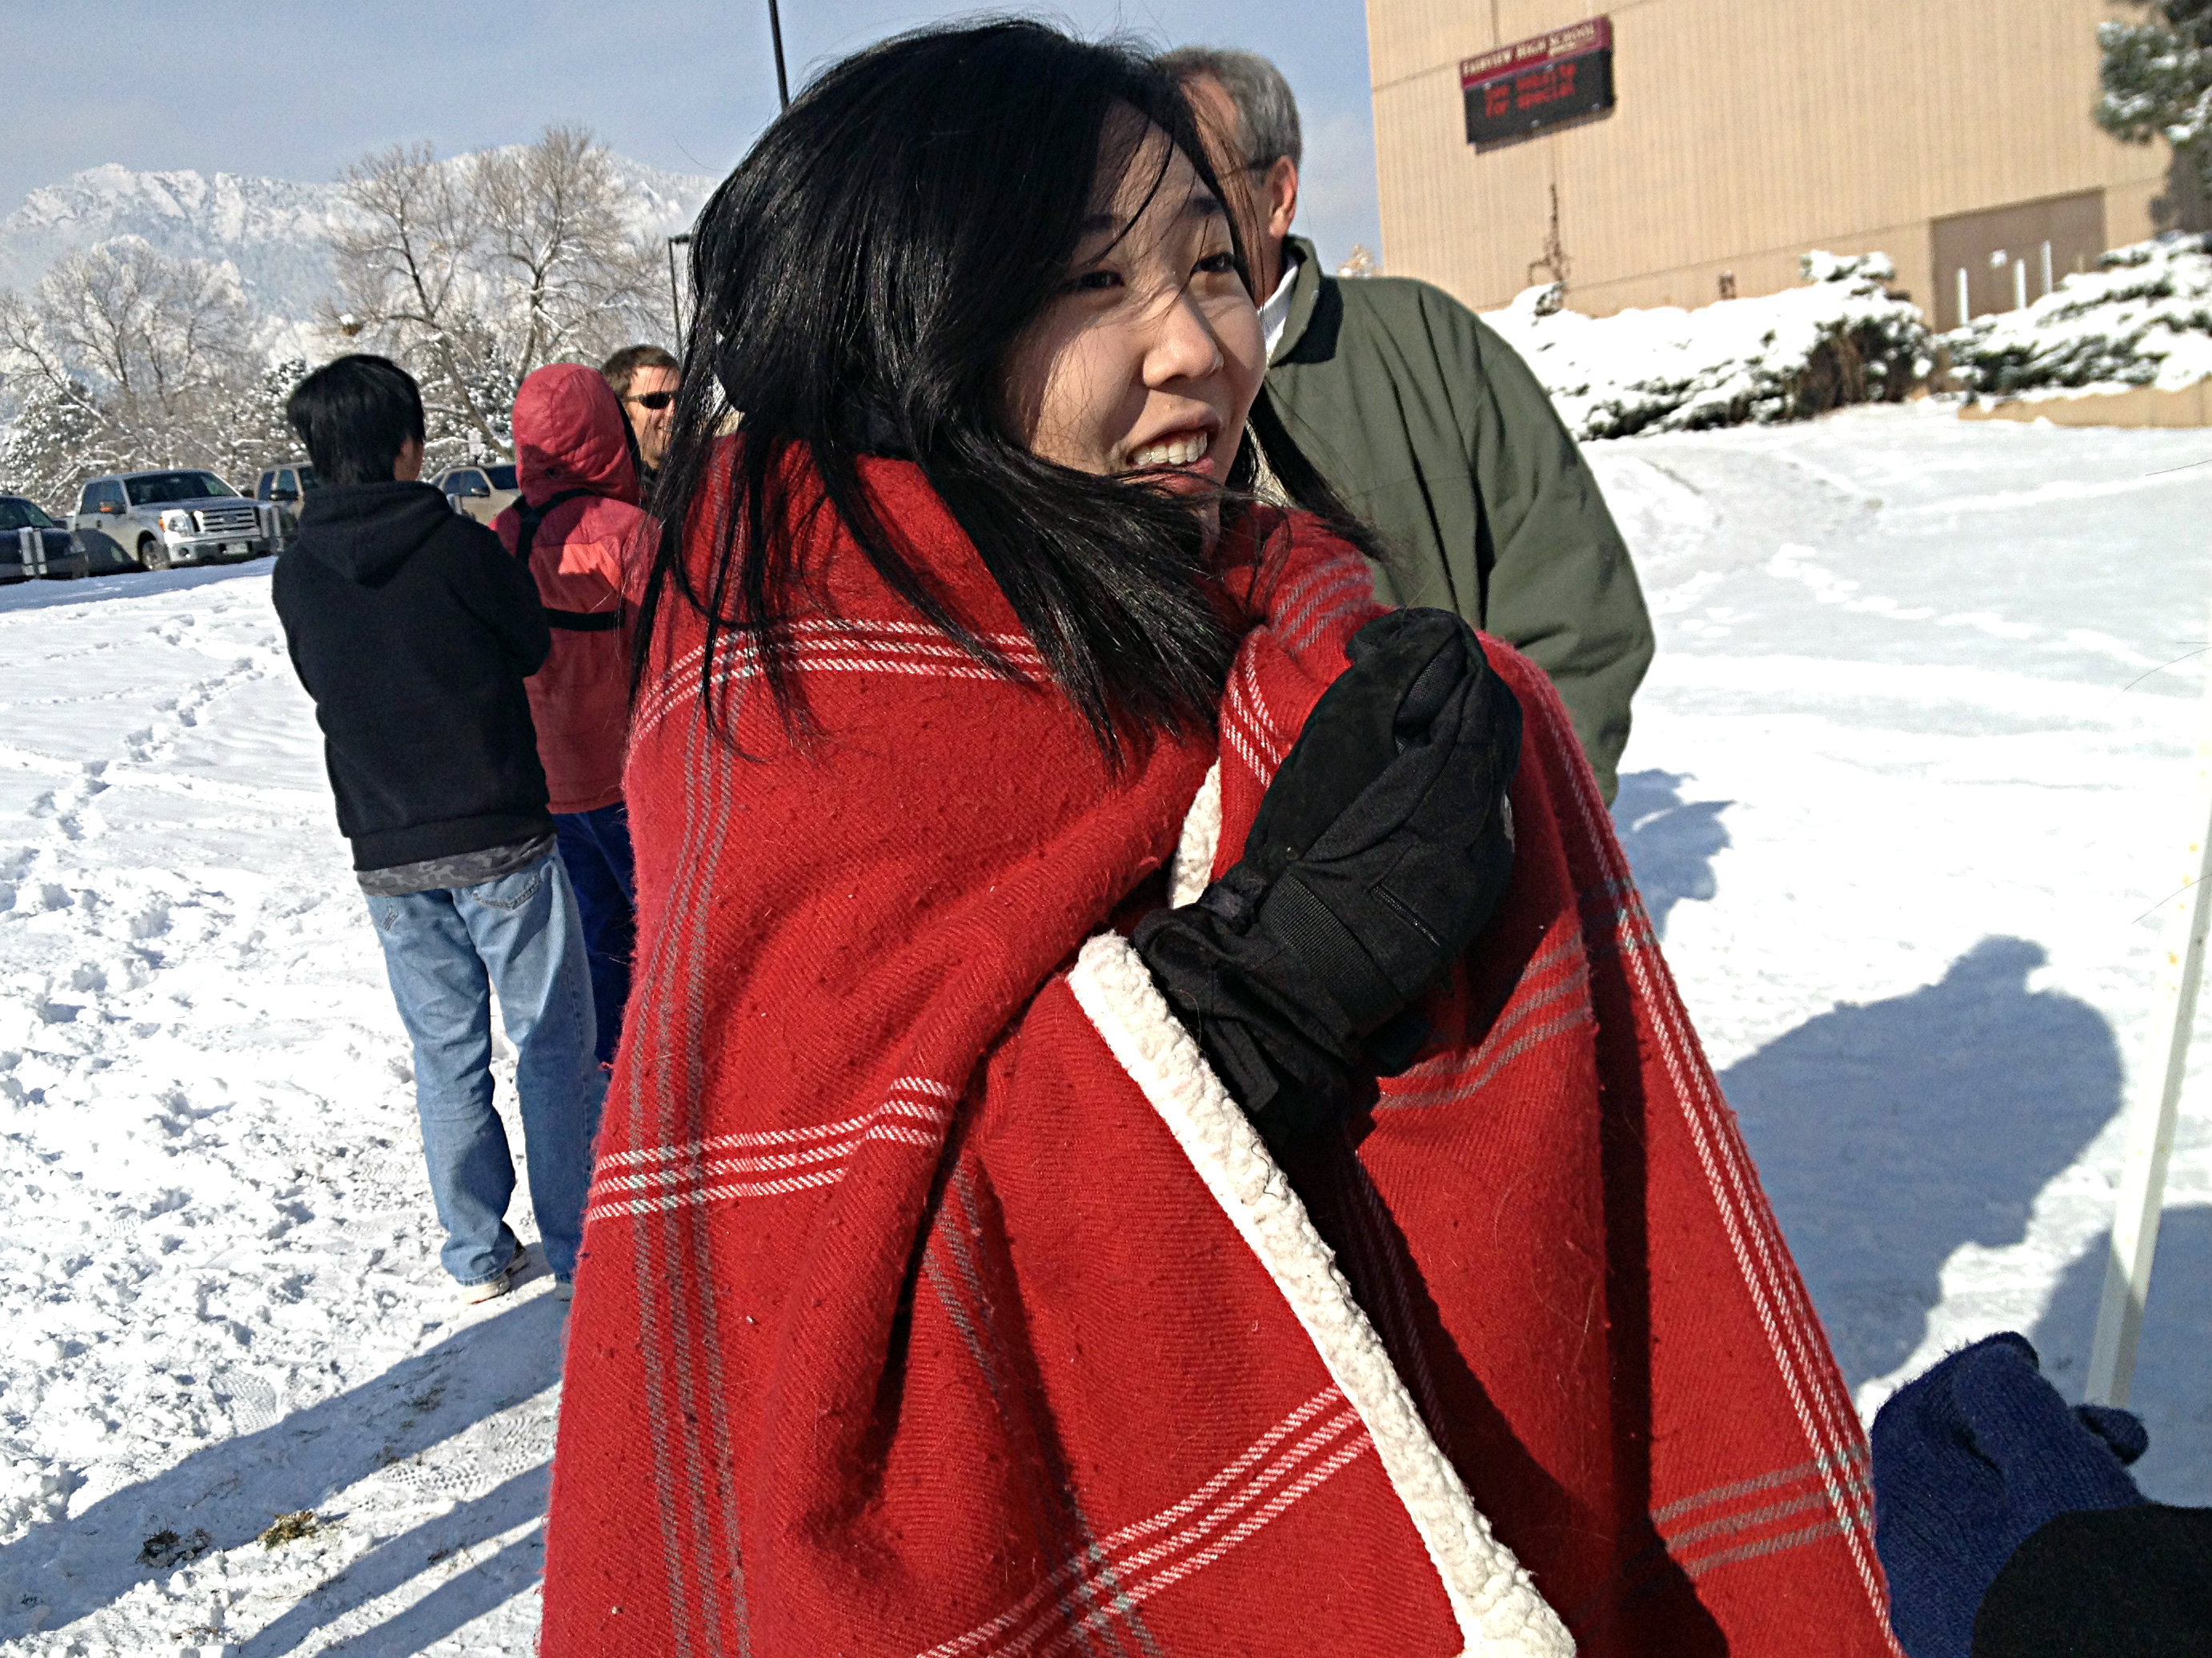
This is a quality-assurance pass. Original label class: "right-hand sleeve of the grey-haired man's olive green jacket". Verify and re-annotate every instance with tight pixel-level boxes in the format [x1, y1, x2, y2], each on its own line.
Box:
[1436, 309, 1653, 805]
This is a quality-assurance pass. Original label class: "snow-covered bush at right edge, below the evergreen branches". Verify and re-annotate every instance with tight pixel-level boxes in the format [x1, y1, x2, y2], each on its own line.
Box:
[1942, 232, 2212, 396]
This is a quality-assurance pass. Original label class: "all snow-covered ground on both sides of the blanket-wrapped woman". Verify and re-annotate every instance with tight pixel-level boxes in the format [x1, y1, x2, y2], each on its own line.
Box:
[0, 406, 2212, 1656]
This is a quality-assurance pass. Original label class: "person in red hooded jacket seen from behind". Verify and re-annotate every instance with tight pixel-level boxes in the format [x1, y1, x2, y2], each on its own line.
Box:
[493, 362, 652, 1063]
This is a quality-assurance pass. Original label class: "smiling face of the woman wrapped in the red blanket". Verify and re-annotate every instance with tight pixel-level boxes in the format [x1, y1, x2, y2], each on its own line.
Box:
[1007, 110, 1268, 535]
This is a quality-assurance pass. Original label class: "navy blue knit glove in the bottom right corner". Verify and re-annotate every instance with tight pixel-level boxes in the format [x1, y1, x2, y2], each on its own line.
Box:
[1871, 1331, 2148, 1658]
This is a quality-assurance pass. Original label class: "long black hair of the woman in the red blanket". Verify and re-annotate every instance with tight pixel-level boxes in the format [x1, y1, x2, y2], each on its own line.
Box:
[637, 20, 1340, 759]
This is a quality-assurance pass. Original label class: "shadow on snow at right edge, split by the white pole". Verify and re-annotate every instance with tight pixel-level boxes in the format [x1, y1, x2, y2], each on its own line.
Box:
[2029, 1205, 2212, 1505]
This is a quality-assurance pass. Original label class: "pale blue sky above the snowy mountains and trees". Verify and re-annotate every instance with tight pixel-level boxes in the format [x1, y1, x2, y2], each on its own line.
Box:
[0, 0, 1380, 261]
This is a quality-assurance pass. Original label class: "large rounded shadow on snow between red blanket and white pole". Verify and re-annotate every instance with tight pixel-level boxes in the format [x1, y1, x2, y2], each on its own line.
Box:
[1721, 937, 2122, 1391]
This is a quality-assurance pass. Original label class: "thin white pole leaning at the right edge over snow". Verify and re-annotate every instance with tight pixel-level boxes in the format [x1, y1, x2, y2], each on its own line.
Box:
[2086, 596, 2212, 1404]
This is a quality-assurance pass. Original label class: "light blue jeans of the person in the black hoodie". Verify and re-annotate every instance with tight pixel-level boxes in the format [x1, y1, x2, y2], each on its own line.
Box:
[370, 853, 606, 1284]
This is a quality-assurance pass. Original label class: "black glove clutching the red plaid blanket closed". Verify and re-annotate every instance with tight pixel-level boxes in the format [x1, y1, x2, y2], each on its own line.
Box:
[1135, 610, 1522, 1143]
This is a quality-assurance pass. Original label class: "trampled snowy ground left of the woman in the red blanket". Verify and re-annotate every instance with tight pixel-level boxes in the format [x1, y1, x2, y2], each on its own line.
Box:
[0, 563, 559, 1653]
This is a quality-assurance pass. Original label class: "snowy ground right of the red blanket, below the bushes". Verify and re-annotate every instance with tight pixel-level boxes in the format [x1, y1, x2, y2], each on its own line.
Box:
[1586, 405, 2212, 1504]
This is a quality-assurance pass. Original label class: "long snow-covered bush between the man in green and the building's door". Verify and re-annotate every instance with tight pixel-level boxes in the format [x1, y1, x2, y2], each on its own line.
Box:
[1482, 252, 1929, 440]
